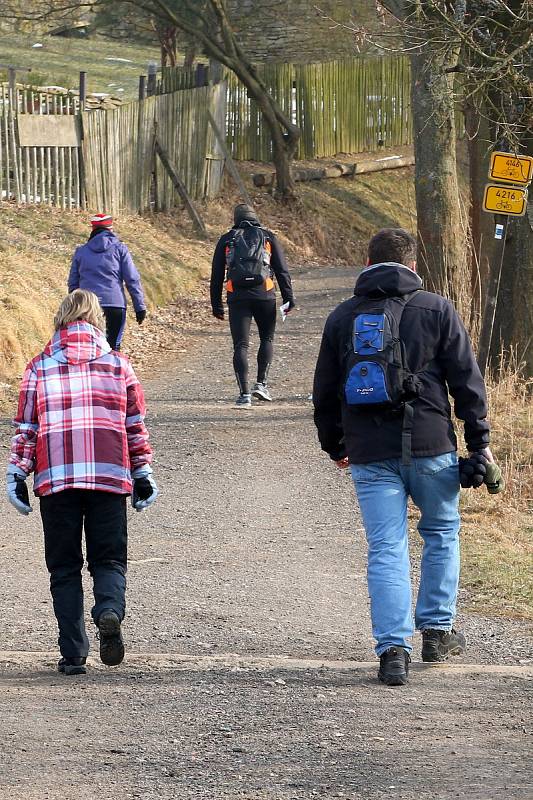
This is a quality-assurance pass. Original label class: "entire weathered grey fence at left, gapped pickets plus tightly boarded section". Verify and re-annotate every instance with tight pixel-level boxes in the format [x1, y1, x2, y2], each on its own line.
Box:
[0, 83, 227, 213]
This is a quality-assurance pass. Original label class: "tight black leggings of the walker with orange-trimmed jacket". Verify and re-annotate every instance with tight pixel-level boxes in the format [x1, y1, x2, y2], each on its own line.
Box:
[228, 298, 276, 394]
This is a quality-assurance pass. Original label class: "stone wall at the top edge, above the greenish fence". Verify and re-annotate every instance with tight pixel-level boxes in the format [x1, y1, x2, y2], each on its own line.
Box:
[228, 0, 376, 63]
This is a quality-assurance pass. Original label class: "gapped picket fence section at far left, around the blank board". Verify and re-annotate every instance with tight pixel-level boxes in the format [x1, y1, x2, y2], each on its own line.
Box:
[0, 84, 83, 208]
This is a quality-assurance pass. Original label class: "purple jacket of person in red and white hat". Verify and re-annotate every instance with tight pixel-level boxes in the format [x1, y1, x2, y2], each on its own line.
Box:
[68, 231, 146, 311]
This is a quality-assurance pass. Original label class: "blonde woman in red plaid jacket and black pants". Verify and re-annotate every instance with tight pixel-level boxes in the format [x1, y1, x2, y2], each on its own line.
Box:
[7, 289, 157, 675]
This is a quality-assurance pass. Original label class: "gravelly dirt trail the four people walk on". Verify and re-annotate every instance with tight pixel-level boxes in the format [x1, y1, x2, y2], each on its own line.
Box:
[0, 268, 533, 800]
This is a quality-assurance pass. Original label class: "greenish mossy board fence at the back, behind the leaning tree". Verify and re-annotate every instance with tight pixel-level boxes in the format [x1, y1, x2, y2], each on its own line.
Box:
[162, 56, 412, 162]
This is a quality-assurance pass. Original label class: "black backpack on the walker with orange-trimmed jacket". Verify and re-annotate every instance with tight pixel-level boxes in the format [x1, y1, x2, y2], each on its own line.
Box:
[226, 224, 270, 289]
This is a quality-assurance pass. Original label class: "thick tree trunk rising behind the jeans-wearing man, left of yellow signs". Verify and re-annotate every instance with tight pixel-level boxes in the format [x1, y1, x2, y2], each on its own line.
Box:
[411, 45, 468, 311]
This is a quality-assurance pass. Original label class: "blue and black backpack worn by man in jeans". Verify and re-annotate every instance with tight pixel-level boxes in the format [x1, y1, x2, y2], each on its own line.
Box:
[343, 292, 421, 464]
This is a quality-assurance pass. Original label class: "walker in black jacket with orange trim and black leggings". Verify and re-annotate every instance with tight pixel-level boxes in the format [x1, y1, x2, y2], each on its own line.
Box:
[210, 204, 294, 408]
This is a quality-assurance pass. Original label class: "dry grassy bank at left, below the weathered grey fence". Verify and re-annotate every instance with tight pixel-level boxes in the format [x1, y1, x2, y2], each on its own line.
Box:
[0, 203, 210, 404]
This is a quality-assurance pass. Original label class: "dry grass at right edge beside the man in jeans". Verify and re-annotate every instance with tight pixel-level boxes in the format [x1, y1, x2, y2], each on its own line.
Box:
[461, 368, 533, 619]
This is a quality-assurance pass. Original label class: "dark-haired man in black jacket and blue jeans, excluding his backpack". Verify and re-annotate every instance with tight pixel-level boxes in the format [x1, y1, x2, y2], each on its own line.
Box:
[313, 228, 493, 685]
